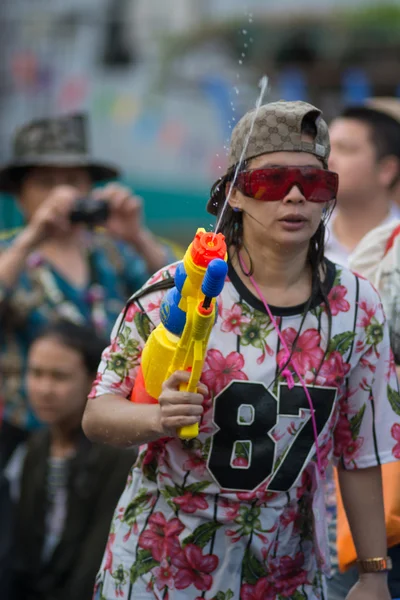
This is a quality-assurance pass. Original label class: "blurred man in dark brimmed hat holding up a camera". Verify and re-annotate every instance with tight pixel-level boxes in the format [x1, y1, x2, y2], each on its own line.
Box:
[0, 115, 180, 467]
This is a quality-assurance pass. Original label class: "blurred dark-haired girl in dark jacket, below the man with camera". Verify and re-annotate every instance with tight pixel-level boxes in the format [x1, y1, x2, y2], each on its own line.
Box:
[5, 322, 136, 600]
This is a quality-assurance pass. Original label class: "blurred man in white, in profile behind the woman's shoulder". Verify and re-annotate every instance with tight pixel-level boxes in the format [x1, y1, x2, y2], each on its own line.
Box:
[325, 98, 400, 266]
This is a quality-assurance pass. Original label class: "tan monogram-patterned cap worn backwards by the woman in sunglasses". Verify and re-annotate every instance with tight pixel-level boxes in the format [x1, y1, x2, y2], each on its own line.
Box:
[207, 100, 330, 215]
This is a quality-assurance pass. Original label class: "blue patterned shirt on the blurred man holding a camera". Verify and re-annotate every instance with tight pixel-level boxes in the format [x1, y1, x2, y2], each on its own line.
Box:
[0, 227, 180, 430]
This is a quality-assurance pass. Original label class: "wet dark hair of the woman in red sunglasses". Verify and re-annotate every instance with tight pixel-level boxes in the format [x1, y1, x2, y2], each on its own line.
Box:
[211, 113, 335, 372]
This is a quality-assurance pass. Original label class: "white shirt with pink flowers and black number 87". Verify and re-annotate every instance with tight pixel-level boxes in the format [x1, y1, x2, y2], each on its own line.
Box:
[91, 262, 400, 600]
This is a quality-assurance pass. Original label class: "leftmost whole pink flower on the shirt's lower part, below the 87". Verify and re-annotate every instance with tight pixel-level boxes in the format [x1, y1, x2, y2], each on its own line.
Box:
[139, 512, 184, 562]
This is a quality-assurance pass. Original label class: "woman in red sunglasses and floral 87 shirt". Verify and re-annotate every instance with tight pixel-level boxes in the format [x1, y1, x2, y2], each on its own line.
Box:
[83, 102, 400, 600]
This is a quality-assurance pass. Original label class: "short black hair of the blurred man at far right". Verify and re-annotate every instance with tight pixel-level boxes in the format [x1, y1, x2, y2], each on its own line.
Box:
[339, 106, 400, 189]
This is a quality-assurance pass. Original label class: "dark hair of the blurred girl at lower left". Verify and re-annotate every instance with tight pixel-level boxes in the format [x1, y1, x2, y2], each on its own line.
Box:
[33, 320, 108, 376]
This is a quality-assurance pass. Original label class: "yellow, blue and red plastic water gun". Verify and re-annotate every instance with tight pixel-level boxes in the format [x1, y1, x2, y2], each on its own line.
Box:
[131, 229, 228, 439]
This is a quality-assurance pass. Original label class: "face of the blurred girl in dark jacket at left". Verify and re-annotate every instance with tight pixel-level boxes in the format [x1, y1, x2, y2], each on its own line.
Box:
[27, 337, 92, 426]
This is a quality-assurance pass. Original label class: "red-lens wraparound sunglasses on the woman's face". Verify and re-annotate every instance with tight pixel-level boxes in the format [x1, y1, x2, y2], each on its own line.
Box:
[235, 167, 339, 202]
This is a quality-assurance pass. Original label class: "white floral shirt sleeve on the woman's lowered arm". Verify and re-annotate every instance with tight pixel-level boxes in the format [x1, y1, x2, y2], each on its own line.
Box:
[334, 281, 400, 469]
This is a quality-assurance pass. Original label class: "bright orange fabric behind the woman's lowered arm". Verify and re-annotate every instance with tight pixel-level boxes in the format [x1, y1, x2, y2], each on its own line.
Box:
[335, 462, 400, 572]
